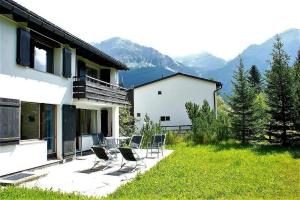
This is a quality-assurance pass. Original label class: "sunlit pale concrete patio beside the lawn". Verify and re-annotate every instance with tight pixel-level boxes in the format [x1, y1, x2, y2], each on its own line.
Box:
[21, 150, 172, 197]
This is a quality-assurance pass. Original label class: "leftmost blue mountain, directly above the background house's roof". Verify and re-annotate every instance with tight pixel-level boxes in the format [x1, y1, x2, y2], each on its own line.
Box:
[93, 37, 196, 87]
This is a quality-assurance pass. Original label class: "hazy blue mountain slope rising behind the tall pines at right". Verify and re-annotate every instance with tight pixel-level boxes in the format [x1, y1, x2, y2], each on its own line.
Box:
[203, 29, 300, 94]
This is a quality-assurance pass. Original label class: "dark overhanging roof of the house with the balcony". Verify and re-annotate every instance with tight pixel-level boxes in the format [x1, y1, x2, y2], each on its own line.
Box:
[0, 0, 128, 70]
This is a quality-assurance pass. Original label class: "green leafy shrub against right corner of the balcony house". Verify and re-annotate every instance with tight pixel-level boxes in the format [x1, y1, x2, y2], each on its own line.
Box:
[119, 106, 136, 136]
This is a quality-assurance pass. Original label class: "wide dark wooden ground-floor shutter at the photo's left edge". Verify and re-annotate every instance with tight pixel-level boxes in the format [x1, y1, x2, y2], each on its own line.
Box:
[0, 98, 20, 145]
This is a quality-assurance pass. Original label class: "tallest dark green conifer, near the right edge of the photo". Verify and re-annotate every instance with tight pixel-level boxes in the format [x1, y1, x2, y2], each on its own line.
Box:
[266, 35, 294, 145]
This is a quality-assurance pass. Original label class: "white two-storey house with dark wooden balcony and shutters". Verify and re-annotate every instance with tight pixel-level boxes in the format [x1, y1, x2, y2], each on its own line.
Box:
[0, 0, 127, 176]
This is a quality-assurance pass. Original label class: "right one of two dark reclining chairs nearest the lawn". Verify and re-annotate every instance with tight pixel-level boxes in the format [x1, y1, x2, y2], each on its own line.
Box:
[119, 147, 146, 171]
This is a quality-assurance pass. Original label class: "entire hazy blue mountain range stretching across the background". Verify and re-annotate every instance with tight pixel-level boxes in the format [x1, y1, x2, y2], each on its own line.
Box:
[93, 29, 300, 94]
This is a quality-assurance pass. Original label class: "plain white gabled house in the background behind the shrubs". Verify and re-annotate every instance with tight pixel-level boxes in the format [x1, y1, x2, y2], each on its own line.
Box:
[129, 73, 222, 128]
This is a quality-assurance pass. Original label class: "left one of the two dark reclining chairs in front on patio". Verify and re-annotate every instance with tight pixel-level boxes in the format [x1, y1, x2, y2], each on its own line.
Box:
[91, 146, 115, 170]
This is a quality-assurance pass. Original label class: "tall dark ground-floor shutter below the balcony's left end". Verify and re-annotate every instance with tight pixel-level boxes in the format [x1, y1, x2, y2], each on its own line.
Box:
[62, 105, 76, 156]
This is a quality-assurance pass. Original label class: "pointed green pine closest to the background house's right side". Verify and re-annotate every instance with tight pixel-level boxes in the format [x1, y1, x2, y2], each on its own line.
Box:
[229, 58, 255, 144]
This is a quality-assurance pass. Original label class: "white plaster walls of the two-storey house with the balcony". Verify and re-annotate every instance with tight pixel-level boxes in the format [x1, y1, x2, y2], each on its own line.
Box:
[0, 11, 125, 176]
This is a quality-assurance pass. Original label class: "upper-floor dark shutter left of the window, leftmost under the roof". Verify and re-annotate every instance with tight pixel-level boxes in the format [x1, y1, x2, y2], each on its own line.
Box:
[17, 28, 30, 66]
